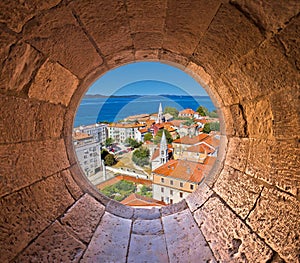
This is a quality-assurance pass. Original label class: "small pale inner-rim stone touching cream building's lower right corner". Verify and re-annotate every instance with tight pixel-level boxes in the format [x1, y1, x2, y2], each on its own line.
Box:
[185, 183, 213, 212]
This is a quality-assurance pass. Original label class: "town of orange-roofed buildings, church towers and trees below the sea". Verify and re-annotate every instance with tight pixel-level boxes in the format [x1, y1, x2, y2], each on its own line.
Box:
[73, 103, 220, 207]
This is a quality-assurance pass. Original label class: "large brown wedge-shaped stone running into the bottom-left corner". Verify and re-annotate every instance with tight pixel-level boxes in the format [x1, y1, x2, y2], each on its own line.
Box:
[0, 175, 74, 262]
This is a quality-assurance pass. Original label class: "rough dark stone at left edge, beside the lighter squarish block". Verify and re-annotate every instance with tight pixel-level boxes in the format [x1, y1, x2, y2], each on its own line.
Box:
[0, 43, 43, 94]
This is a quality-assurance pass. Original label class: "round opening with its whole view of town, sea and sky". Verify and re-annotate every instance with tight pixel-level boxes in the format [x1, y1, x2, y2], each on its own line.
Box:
[72, 62, 221, 208]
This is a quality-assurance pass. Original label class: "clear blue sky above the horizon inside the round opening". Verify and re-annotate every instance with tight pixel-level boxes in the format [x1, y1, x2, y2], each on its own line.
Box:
[87, 62, 208, 96]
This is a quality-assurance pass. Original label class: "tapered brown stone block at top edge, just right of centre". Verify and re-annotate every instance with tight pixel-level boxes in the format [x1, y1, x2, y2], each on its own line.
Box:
[163, 0, 221, 56]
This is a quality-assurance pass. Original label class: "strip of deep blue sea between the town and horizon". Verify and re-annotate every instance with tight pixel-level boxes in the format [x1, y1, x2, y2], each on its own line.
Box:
[74, 95, 215, 127]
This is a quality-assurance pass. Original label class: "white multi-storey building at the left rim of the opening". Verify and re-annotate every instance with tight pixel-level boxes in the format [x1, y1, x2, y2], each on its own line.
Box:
[73, 132, 101, 177]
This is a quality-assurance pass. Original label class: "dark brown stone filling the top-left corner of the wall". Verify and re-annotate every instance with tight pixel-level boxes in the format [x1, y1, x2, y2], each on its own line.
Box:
[0, 0, 61, 32]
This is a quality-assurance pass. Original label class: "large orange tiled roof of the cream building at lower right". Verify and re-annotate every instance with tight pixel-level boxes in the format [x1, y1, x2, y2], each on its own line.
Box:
[153, 160, 206, 183]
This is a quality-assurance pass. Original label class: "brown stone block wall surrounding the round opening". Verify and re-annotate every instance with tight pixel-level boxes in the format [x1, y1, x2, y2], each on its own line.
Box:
[0, 0, 300, 262]
